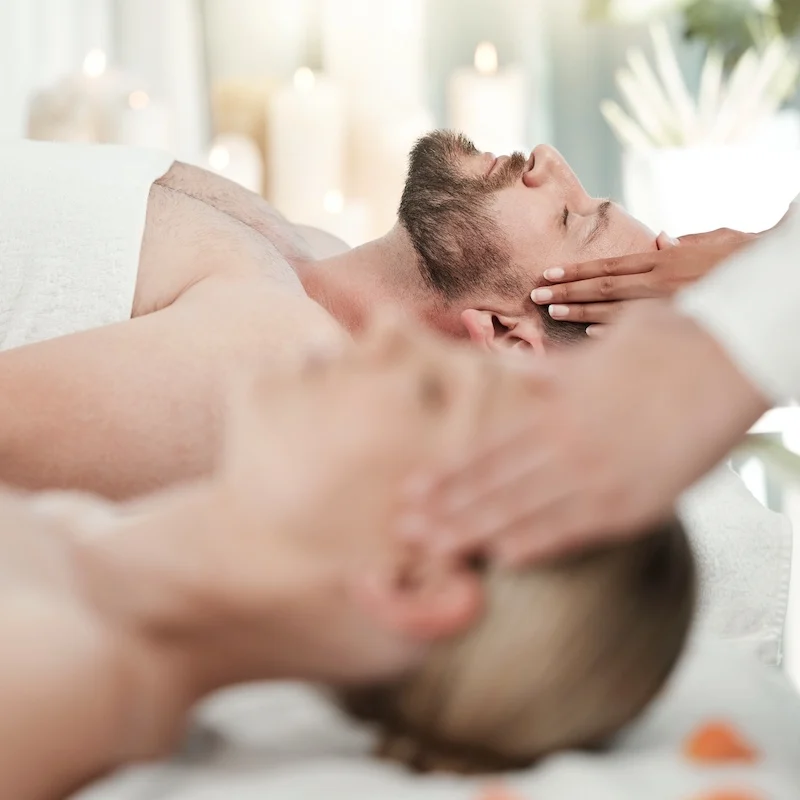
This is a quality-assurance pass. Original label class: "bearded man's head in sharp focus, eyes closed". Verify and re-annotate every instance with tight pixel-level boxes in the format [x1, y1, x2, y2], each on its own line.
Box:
[399, 131, 656, 350]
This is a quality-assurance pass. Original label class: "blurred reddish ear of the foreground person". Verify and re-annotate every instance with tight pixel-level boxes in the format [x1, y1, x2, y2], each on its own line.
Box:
[356, 551, 483, 642]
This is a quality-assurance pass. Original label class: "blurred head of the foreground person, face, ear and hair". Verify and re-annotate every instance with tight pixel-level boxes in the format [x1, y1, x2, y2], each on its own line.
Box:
[268, 327, 693, 771]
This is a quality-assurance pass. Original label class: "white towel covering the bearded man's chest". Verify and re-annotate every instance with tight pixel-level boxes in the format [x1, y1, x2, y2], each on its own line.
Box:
[0, 140, 173, 350]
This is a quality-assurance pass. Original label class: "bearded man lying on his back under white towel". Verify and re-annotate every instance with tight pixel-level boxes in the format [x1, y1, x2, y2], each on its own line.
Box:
[0, 132, 656, 498]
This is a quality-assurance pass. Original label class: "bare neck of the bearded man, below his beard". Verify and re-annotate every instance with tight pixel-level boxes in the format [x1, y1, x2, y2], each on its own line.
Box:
[295, 226, 441, 333]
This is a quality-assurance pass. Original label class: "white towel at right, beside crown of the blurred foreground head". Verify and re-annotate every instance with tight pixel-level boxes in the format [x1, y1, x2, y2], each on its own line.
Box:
[680, 467, 792, 664]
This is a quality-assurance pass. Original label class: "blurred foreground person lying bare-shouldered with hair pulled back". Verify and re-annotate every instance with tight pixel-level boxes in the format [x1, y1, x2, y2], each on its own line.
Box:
[0, 322, 694, 800]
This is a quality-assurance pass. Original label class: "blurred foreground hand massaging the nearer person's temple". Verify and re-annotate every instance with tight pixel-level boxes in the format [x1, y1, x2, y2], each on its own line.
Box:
[398, 303, 769, 563]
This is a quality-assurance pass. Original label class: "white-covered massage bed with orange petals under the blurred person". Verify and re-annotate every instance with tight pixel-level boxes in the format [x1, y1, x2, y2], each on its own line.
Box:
[75, 470, 800, 800]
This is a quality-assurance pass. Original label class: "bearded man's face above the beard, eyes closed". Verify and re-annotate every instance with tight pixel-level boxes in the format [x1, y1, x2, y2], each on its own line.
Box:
[462, 145, 656, 288]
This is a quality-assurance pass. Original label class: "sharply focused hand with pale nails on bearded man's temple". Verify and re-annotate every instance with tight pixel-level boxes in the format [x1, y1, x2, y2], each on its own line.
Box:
[531, 228, 756, 336]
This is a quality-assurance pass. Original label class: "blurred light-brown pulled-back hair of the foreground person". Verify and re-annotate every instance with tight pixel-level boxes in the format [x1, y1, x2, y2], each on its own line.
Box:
[341, 521, 694, 772]
